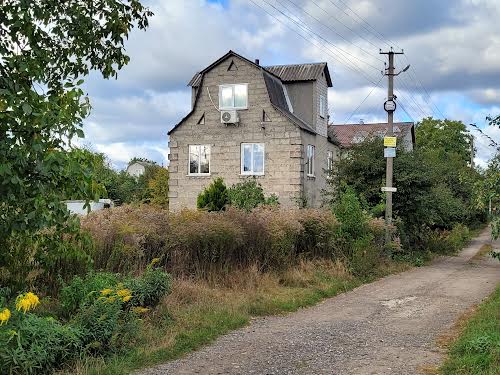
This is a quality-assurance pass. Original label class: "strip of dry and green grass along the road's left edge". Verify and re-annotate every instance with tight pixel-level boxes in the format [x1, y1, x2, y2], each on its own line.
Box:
[60, 260, 410, 375]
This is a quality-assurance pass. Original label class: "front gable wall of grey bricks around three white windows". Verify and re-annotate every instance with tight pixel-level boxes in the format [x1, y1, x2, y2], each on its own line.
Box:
[169, 57, 303, 211]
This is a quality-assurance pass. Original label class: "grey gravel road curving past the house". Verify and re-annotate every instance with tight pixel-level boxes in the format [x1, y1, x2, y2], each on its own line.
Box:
[139, 230, 500, 375]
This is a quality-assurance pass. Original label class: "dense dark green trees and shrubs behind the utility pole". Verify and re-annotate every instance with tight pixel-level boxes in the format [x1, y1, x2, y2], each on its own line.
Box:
[331, 118, 486, 253]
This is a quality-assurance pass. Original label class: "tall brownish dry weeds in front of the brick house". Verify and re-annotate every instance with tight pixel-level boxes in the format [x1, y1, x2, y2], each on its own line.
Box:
[82, 206, 383, 279]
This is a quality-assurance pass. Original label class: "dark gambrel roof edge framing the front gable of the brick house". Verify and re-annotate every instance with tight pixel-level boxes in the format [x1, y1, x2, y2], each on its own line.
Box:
[168, 51, 317, 135]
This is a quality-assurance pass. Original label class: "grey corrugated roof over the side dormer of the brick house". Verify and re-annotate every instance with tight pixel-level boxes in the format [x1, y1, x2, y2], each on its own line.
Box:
[265, 62, 333, 87]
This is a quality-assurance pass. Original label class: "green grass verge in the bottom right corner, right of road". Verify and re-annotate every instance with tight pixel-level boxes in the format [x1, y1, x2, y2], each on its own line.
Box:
[439, 286, 500, 375]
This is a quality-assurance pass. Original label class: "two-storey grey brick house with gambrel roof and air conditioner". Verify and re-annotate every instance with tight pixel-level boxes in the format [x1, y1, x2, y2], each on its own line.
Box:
[168, 51, 339, 211]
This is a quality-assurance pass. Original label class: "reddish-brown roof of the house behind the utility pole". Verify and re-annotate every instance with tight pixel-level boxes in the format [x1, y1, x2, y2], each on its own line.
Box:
[328, 122, 415, 148]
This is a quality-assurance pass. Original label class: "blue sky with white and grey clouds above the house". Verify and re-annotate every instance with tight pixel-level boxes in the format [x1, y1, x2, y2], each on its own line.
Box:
[81, 0, 500, 168]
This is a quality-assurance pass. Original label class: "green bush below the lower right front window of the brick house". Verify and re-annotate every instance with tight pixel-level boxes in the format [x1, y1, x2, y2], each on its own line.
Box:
[228, 179, 279, 211]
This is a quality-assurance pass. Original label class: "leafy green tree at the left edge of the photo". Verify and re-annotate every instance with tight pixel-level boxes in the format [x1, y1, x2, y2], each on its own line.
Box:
[0, 0, 152, 290]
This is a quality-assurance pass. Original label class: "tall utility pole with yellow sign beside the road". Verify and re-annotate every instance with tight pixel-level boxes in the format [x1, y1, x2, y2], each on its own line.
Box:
[380, 47, 410, 245]
